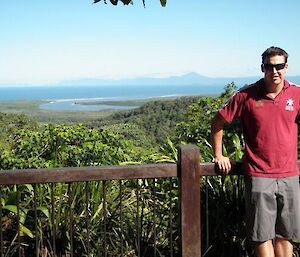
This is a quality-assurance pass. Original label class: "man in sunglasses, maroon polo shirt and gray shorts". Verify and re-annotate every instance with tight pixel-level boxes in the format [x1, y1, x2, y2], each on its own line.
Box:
[211, 46, 300, 257]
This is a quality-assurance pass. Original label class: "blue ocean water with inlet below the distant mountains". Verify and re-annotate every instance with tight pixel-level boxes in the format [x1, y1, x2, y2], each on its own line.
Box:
[0, 85, 224, 111]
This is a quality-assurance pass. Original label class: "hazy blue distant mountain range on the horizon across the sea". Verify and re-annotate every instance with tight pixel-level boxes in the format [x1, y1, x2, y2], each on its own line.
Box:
[56, 72, 300, 87]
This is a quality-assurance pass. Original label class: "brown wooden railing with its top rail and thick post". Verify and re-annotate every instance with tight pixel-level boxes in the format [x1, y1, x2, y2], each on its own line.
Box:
[0, 145, 241, 257]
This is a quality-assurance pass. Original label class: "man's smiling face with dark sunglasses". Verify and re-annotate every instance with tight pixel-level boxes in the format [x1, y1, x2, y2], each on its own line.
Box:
[261, 55, 288, 85]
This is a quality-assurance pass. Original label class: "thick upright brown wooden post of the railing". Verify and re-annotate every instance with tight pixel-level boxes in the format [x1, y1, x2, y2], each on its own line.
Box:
[178, 145, 201, 257]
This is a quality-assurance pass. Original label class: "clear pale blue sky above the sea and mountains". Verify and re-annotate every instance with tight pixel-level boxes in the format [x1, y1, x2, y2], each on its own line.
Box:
[0, 0, 300, 86]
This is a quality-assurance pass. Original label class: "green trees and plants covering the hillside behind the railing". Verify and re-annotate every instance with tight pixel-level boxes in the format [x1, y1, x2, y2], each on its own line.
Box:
[0, 83, 272, 257]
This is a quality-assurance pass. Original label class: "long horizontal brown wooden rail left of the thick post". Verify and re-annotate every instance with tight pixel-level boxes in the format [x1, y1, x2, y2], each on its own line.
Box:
[0, 163, 177, 185]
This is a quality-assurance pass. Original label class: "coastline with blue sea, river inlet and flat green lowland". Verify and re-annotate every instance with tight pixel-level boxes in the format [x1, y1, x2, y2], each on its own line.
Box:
[0, 85, 223, 123]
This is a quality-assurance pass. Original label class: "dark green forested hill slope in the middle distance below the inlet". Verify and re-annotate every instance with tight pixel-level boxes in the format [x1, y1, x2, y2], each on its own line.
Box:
[90, 97, 200, 145]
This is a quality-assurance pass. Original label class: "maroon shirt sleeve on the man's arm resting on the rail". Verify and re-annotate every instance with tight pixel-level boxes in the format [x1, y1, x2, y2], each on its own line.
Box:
[219, 92, 244, 123]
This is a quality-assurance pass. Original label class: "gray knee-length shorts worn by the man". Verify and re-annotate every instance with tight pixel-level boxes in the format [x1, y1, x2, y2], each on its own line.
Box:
[245, 176, 300, 242]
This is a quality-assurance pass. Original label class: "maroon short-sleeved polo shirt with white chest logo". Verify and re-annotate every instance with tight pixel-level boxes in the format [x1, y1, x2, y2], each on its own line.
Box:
[219, 79, 300, 178]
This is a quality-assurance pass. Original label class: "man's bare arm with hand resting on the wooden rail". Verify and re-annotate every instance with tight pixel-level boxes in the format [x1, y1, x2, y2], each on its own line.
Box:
[211, 113, 231, 174]
